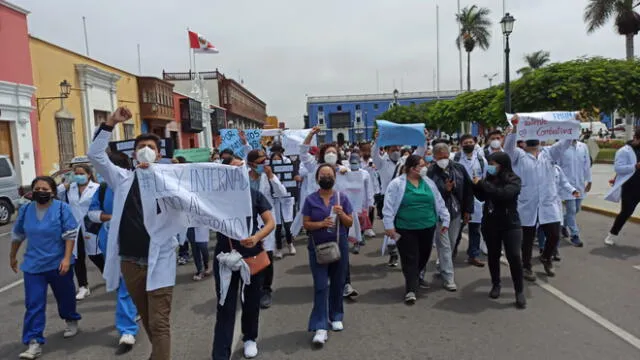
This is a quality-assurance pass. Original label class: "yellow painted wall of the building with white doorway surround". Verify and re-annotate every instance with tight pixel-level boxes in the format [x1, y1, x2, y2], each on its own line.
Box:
[29, 37, 140, 174]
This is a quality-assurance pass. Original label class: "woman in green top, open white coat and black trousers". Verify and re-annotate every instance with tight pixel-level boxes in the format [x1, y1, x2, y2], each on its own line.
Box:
[382, 155, 449, 305]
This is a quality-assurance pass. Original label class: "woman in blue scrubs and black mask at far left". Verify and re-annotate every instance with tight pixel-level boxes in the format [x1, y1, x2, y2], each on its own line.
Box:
[10, 176, 80, 359]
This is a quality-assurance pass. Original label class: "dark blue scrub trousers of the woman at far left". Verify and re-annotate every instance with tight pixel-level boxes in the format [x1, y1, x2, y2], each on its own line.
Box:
[22, 266, 81, 345]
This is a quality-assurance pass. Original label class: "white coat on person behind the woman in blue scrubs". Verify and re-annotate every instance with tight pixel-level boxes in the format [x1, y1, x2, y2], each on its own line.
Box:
[58, 181, 101, 257]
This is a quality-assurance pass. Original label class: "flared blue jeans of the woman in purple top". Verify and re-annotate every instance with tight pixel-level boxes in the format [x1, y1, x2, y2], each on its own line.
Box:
[309, 238, 349, 331]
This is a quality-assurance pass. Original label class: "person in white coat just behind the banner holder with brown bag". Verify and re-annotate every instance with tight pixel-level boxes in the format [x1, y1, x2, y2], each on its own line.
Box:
[242, 150, 287, 309]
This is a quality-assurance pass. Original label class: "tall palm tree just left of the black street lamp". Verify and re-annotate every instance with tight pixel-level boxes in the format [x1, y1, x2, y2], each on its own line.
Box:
[456, 5, 491, 91]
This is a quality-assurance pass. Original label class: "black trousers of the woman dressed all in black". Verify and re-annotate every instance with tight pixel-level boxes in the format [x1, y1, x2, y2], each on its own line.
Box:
[482, 226, 524, 294]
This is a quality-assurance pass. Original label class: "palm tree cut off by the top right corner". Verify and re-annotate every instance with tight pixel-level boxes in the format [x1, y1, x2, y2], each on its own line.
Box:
[584, 0, 640, 60]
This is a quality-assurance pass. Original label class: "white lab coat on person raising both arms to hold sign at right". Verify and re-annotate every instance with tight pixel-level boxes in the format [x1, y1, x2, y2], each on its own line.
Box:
[504, 134, 571, 227]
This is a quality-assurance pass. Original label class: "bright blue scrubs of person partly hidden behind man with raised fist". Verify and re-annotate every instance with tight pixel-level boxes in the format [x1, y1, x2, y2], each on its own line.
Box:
[89, 187, 139, 336]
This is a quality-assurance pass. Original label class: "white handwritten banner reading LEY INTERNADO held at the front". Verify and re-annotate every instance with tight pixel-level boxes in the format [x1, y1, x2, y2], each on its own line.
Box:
[136, 163, 252, 239]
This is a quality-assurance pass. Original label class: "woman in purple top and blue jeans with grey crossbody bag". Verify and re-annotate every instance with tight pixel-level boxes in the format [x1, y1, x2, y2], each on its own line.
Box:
[302, 164, 353, 346]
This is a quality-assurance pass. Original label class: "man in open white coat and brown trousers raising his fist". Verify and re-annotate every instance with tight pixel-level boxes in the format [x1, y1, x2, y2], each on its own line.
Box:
[87, 107, 178, 360]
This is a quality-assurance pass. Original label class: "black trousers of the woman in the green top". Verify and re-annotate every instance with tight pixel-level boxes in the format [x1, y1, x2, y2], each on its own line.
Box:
[396, 227, 435, 293]
